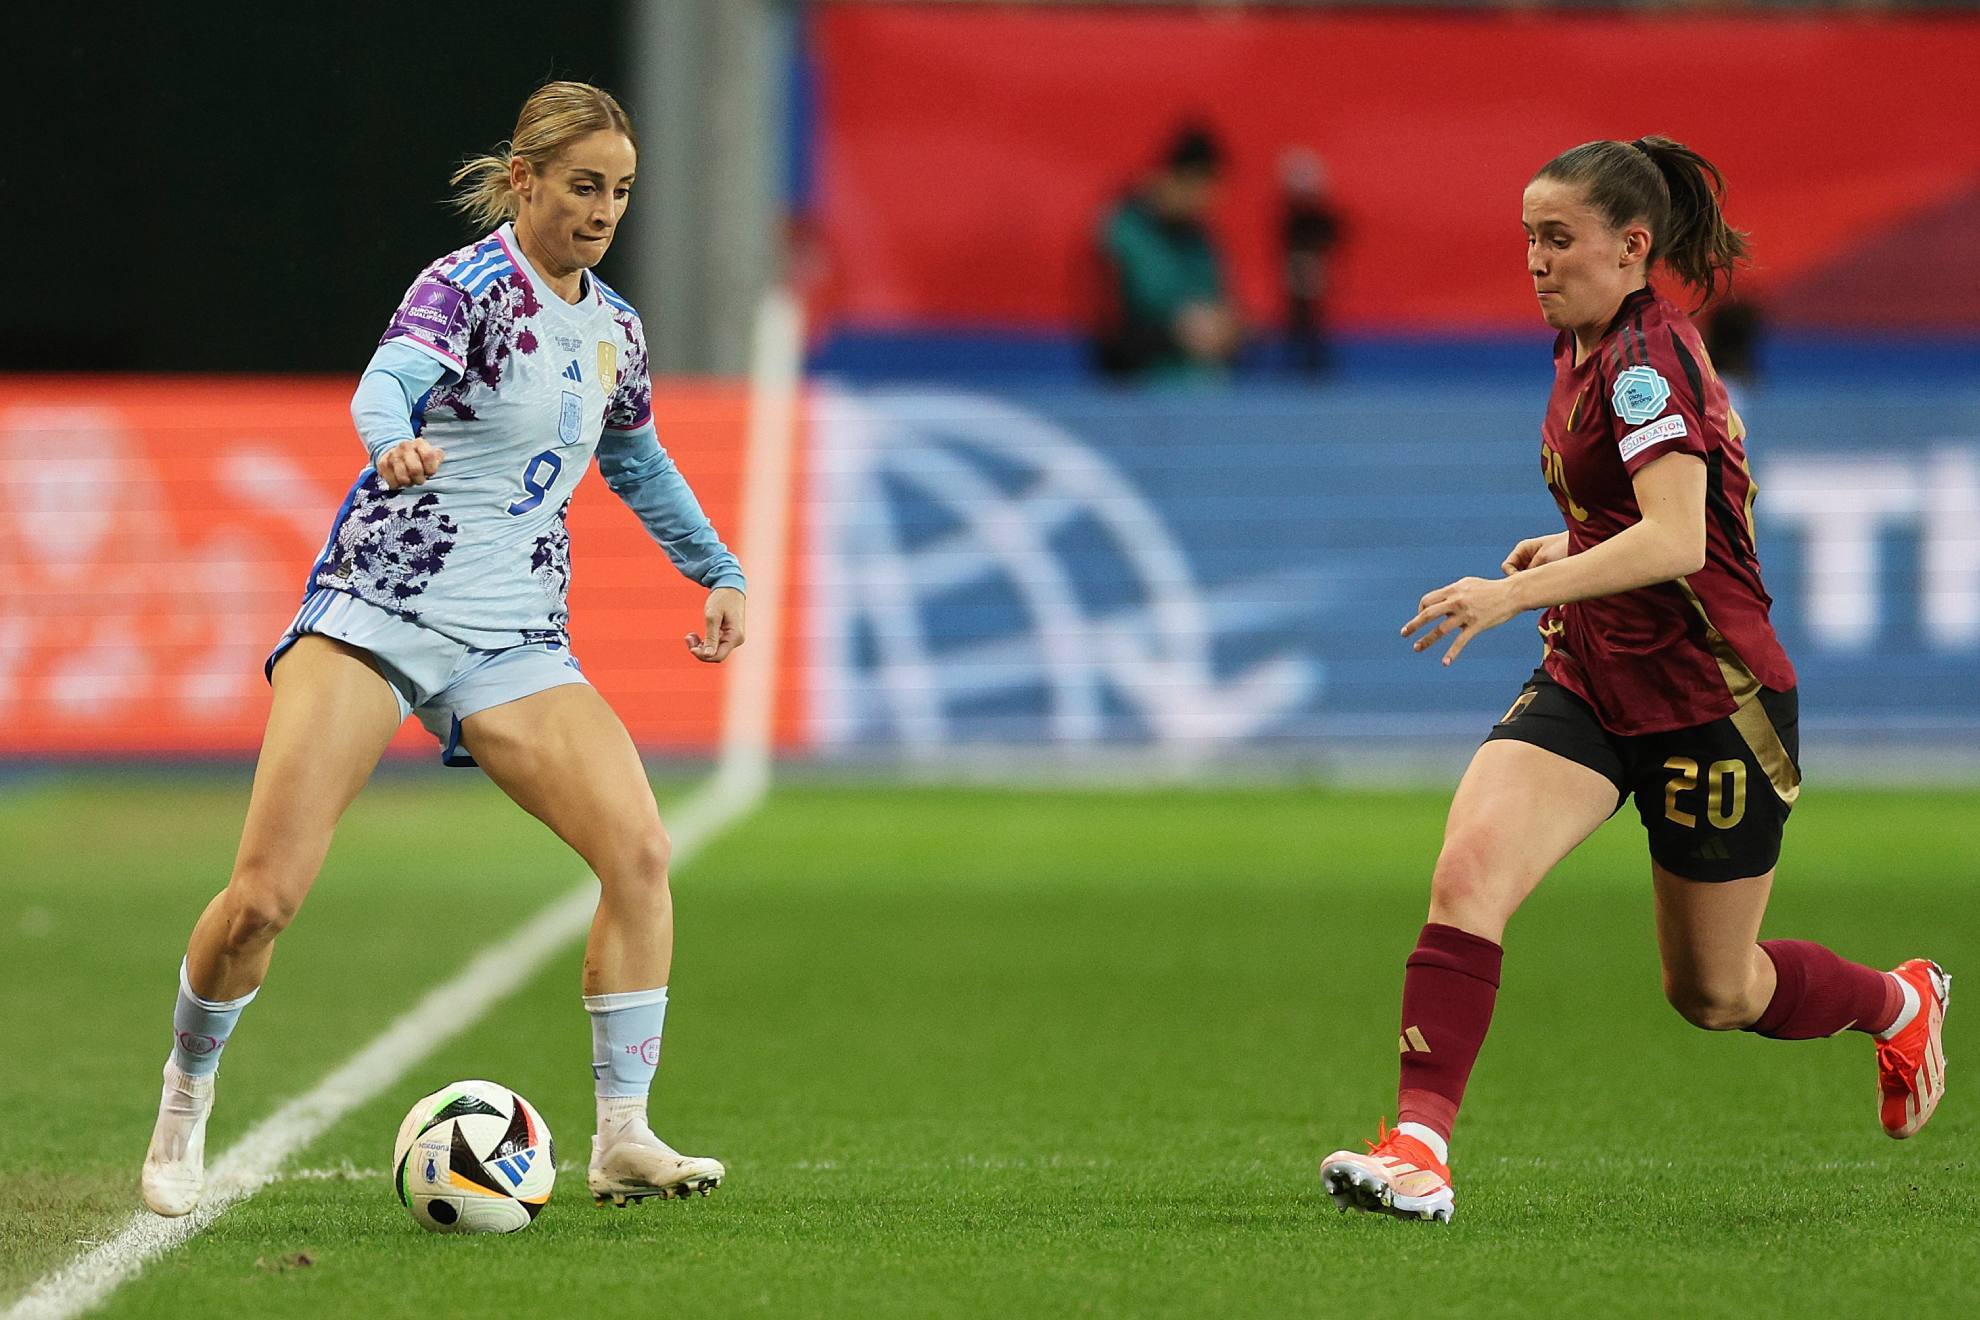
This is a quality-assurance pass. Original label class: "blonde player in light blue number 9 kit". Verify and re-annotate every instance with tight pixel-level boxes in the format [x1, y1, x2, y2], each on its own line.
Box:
[143, 83, 743, 1215]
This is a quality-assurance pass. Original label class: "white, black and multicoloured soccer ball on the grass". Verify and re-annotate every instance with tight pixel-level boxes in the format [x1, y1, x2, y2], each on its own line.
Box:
[392, 1083, 556, 1233]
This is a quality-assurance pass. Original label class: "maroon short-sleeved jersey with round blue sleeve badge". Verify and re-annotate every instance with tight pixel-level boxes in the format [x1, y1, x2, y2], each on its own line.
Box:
[1540, 289, 1794, 734]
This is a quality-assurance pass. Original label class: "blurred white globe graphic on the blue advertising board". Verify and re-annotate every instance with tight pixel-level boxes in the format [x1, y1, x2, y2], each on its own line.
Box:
[812, 390, 1321, 758]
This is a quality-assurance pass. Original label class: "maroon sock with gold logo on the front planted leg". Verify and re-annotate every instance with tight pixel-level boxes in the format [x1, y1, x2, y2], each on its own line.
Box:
[1396, 922, 1505, 1140]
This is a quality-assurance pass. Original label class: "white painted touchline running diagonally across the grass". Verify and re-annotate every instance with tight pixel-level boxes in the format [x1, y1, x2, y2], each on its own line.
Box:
[4, 776, 764, 1320]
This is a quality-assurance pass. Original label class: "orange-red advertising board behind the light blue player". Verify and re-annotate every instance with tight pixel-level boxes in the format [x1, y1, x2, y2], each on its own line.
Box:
[0, 378, 800, 756]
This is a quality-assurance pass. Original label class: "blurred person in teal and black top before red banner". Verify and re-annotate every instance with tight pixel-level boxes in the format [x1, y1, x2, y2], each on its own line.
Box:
[1093, 123, 1241, 384]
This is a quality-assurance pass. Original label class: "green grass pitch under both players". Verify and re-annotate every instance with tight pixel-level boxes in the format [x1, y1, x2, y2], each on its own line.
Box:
[0, 772, 1980, 1316]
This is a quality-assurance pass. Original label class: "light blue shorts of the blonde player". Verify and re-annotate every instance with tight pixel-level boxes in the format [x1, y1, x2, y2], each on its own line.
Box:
[263, 588, 588, 766]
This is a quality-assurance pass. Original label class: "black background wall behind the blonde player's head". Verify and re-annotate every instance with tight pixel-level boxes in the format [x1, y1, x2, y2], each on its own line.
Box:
[0, 0, 628, 372]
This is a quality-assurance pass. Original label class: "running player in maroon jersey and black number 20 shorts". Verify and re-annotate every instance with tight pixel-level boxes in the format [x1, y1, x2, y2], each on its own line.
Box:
[1321, 137, 1950, 1221]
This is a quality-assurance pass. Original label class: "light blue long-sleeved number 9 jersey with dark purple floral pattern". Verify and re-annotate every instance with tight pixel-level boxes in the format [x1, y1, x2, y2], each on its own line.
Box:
[309, 226, 744, 651]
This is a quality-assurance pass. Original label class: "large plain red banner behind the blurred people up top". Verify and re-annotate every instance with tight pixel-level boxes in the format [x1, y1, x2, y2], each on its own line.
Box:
[812, 4, 1980, 330]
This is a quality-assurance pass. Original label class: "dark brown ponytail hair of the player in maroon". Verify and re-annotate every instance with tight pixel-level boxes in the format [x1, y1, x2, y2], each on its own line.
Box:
[1535, 135, 1746, 309]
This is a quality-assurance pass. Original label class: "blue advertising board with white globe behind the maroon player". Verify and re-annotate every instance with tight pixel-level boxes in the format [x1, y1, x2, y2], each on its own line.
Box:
[804, 381, 1980, 775]
